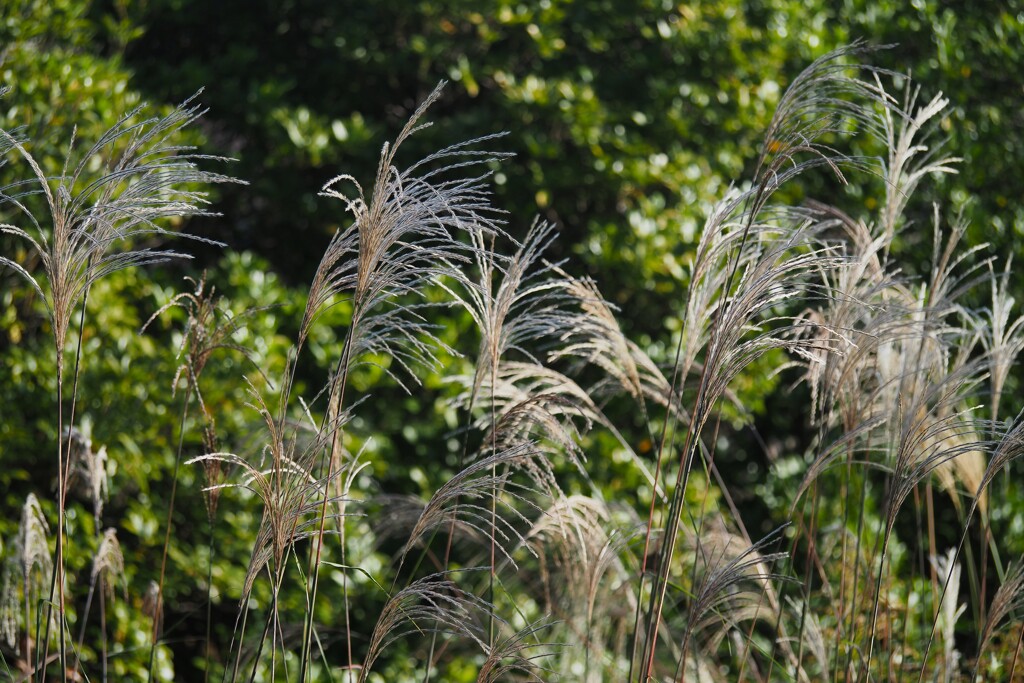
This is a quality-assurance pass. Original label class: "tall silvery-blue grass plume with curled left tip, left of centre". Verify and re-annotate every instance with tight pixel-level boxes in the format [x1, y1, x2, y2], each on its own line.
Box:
[298, 82, 509, 389]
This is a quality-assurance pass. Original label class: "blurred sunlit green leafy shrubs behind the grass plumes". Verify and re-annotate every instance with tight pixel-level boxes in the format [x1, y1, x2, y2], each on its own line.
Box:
[0, 0, 1024, 680]
